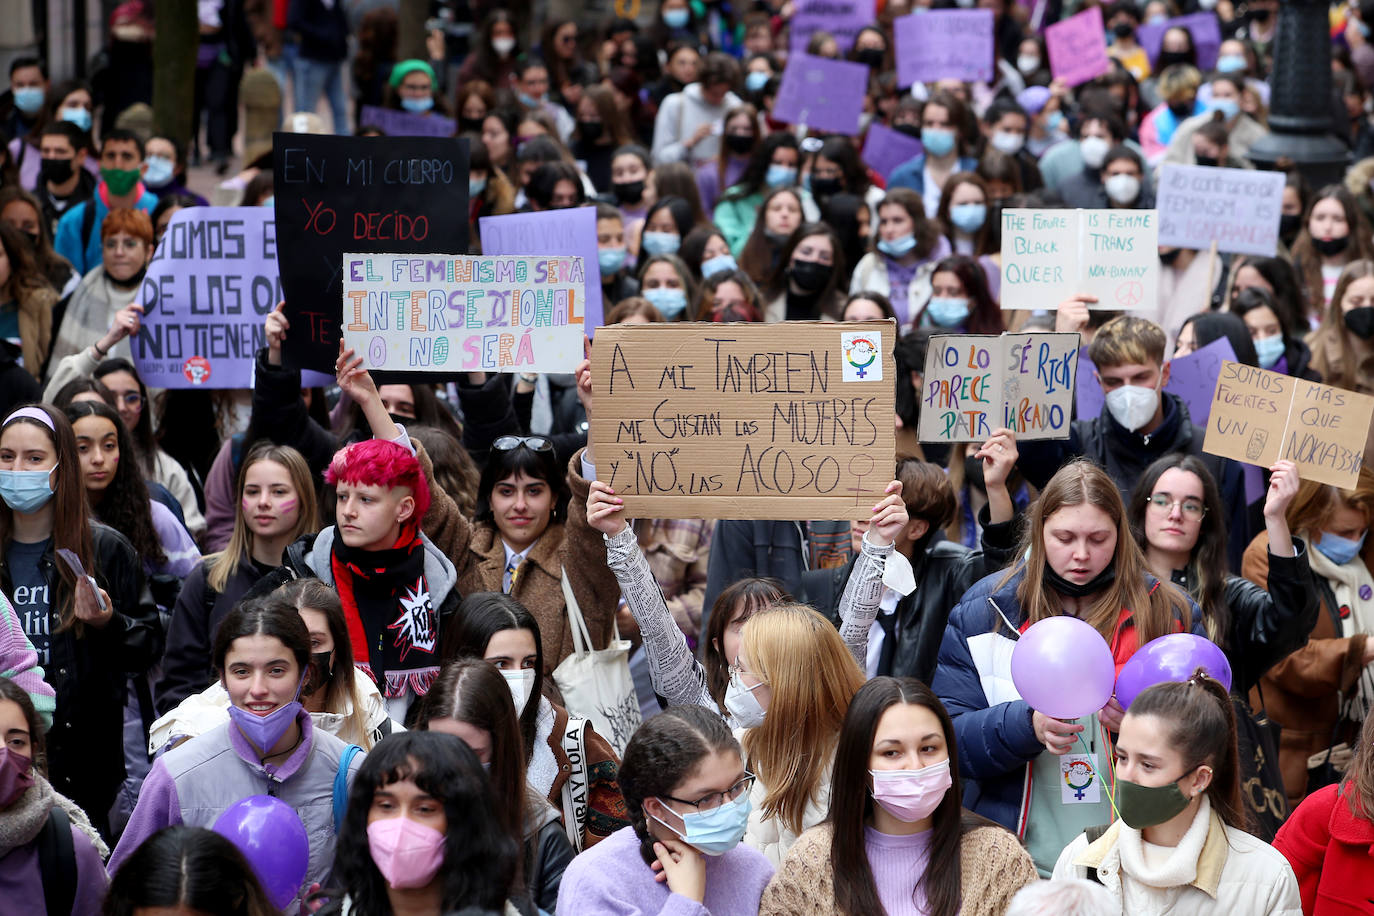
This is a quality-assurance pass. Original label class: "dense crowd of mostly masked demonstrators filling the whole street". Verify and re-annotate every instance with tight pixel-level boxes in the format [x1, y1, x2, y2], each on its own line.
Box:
[0, 0, 1374, 916]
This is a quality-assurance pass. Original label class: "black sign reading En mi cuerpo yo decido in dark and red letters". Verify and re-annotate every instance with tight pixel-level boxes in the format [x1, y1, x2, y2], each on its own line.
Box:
[272, 133, 467, 374]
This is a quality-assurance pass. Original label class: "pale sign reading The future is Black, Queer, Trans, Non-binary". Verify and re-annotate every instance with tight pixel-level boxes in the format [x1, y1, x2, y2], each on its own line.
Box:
[1002, 209, 1160, 309]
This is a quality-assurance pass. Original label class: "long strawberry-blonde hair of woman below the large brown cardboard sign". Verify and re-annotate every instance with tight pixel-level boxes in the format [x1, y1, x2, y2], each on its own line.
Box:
[741, 604, 864, 834]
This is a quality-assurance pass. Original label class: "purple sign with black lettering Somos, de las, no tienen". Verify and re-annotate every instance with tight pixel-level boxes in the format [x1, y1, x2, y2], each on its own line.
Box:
[131, 207, 282, 389]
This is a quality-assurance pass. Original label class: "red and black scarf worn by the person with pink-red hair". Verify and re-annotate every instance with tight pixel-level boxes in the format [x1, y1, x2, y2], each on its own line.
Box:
[330, 526, 438, 696]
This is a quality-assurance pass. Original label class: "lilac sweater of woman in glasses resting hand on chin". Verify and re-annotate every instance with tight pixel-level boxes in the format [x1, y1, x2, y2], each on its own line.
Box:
[558, 827, 772, 916]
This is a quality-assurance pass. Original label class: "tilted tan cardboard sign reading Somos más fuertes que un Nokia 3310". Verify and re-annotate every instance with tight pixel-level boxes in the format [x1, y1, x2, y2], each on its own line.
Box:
[1202, 363, 1374, 489]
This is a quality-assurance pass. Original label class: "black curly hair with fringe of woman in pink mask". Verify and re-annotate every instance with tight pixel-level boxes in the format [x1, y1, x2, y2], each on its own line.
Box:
[334, 725, 519, 916]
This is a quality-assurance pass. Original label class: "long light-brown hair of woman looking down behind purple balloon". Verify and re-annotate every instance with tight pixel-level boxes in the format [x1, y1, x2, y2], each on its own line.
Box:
[999, 459, 1193, 645]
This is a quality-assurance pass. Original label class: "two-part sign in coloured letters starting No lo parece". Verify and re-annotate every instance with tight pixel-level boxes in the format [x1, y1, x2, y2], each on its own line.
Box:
[918, 334, 1079, 442]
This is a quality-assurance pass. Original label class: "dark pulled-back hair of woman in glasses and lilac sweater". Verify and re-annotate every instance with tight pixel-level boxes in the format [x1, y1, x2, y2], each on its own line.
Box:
[620, 706, 743, 865]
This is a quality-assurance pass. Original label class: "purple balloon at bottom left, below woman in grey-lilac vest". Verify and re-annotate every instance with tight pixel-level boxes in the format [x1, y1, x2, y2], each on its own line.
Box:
[214, 795, 311, 909]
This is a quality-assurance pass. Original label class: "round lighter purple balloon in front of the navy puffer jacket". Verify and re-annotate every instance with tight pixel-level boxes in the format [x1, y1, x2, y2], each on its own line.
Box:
[1011, 617, 1116, 718]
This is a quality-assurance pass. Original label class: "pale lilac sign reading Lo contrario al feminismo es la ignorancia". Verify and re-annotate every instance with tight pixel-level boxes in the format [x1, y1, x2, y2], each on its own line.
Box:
[1156, 162, 1285, 258]
